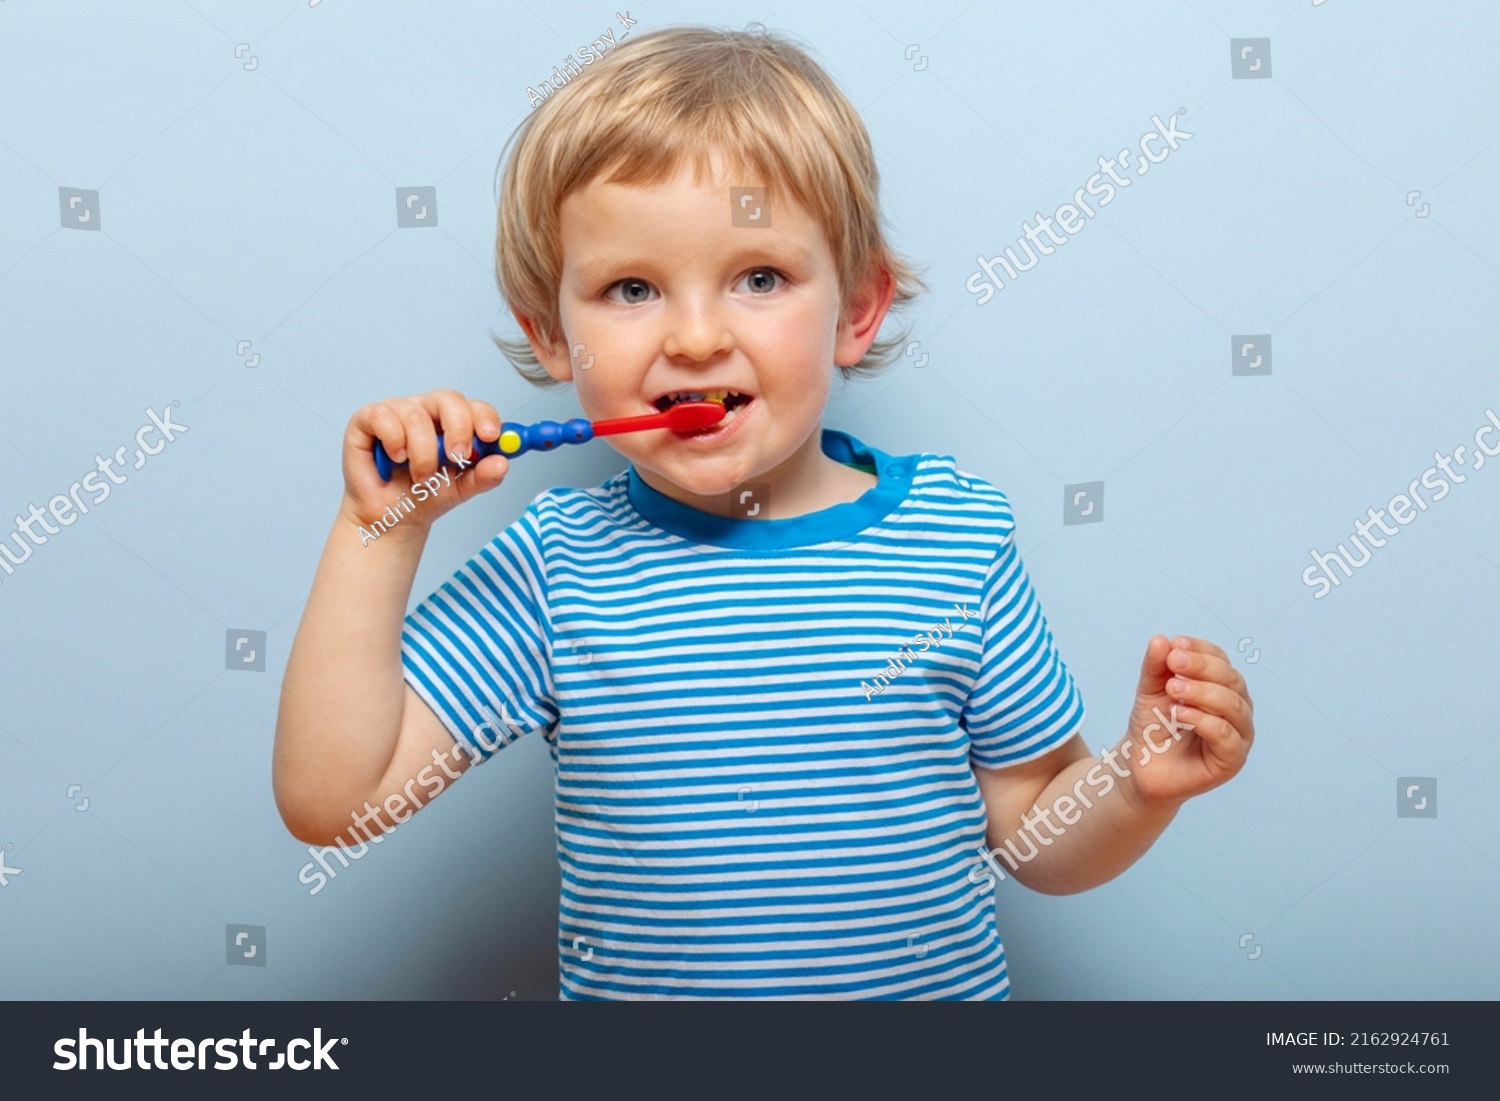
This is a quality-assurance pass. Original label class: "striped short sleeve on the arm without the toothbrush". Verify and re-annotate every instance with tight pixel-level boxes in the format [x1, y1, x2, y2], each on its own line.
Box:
[963, 533, 1085, 768]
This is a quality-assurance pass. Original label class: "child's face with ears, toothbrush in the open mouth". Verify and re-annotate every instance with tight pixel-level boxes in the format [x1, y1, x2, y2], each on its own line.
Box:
[524, 156, 890, 509]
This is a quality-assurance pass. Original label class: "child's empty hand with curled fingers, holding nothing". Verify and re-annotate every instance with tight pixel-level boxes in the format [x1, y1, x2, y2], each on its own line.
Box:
[1121, 635, 1256, 806]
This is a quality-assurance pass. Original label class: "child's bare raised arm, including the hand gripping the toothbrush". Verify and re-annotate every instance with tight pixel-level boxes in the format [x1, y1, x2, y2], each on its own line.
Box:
[272, 390, 507, 845]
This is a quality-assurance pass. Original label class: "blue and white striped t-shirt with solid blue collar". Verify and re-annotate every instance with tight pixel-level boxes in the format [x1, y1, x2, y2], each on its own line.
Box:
[402, 429, 1083, 1001]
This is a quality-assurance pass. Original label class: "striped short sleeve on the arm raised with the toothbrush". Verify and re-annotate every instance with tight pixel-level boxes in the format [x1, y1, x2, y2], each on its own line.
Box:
[401, 501, 558, 759]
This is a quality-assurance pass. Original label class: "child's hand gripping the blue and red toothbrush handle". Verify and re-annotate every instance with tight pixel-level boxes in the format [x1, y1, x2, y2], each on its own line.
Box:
[341, 390, 510, 533]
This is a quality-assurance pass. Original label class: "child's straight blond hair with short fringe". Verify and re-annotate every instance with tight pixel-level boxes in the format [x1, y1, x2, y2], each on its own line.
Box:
[494, 24, 926, 386]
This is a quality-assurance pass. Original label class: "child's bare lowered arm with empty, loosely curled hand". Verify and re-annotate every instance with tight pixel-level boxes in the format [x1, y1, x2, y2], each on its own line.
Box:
[974, 636, 1254, 894]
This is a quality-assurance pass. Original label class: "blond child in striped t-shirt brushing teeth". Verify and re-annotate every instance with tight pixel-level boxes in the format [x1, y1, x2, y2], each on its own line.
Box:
[275, 21, 1253, 999]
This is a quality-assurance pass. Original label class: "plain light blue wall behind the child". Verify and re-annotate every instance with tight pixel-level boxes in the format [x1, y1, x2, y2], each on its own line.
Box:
[0, 0, 1500, 999]
